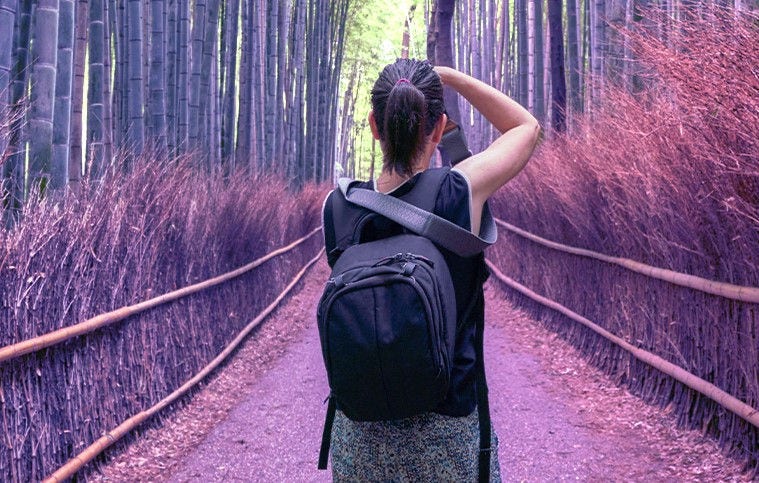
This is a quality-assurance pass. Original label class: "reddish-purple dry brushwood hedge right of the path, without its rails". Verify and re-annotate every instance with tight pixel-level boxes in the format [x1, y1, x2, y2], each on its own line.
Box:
[490, 10, 759, 471]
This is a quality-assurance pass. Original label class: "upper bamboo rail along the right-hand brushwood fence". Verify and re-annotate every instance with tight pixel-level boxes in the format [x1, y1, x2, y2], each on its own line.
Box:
[495, 218, 759, 303]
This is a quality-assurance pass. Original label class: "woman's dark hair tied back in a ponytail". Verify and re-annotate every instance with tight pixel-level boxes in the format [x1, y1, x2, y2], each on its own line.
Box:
[372, 59, 445, 175]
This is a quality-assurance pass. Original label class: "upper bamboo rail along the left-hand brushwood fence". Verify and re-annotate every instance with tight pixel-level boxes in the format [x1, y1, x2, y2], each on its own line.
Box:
[0, 227, 321, 363]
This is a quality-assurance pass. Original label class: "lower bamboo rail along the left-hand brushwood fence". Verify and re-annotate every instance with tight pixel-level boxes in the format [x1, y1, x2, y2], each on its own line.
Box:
[43, 251, 324, 483]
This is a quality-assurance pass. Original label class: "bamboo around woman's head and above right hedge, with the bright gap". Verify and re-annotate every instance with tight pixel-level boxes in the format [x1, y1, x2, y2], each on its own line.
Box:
[337, 0, 757, 177]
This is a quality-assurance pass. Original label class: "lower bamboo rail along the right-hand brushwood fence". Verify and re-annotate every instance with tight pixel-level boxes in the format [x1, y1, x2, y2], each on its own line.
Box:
[486, 260, 759, 428]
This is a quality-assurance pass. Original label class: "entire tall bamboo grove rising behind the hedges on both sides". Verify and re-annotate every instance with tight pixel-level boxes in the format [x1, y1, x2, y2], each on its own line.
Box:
[0, 0, 751, 211]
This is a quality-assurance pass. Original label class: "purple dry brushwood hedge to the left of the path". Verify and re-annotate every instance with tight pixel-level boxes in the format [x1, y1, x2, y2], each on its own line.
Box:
[0, 159, 324, 481]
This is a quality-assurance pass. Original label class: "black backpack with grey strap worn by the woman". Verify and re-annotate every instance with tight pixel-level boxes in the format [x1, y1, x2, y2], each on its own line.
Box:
[317, 169, 496, 480]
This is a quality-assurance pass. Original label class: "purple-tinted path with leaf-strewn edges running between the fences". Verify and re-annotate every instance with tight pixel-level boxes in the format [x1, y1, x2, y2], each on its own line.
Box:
[93, 263, 745, 482]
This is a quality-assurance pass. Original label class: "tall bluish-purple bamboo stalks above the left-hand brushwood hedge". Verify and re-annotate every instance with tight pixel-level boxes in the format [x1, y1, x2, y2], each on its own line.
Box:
[0, 0, 350, 217]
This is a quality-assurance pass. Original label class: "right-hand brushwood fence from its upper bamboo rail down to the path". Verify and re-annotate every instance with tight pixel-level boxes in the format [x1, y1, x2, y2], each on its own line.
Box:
[488, 214, 759, 474]
